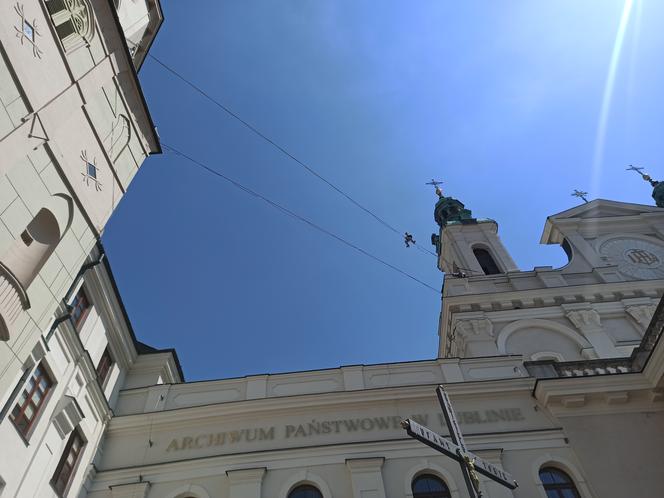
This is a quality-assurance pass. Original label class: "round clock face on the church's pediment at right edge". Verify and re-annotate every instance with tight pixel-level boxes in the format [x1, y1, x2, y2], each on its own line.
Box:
[599, 237, 664, 279]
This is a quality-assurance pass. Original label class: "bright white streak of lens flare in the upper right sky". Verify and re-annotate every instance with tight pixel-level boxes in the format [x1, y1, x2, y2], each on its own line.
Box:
[591, 0, 638, 197]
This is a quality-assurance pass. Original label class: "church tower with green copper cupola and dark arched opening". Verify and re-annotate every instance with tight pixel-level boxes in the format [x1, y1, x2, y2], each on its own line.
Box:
[432, 188, 518, 276]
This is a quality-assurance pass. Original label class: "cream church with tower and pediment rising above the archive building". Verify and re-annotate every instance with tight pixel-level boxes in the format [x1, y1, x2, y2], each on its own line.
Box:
[432, 190, 664, 361]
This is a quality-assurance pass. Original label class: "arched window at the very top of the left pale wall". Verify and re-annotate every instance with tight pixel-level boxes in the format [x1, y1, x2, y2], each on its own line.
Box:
[46, 0, 95, 50]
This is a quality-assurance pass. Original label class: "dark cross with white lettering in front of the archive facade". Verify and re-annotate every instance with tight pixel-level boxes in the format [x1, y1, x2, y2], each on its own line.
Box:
[401, 386, 518, 498]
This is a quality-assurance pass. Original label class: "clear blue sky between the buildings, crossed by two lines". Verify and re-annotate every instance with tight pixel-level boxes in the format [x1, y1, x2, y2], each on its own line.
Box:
[103, 0, 664, 380]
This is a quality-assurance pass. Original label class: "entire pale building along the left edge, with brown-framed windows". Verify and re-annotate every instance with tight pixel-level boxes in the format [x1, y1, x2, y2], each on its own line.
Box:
[0, 0, 171, 498]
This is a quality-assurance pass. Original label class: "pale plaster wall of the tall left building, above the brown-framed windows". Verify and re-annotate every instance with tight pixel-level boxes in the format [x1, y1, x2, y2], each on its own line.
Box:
[0, 0, 159, 402]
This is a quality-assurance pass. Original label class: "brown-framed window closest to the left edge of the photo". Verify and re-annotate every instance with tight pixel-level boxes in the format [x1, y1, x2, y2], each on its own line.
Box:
[7, 361, 57, 443]
